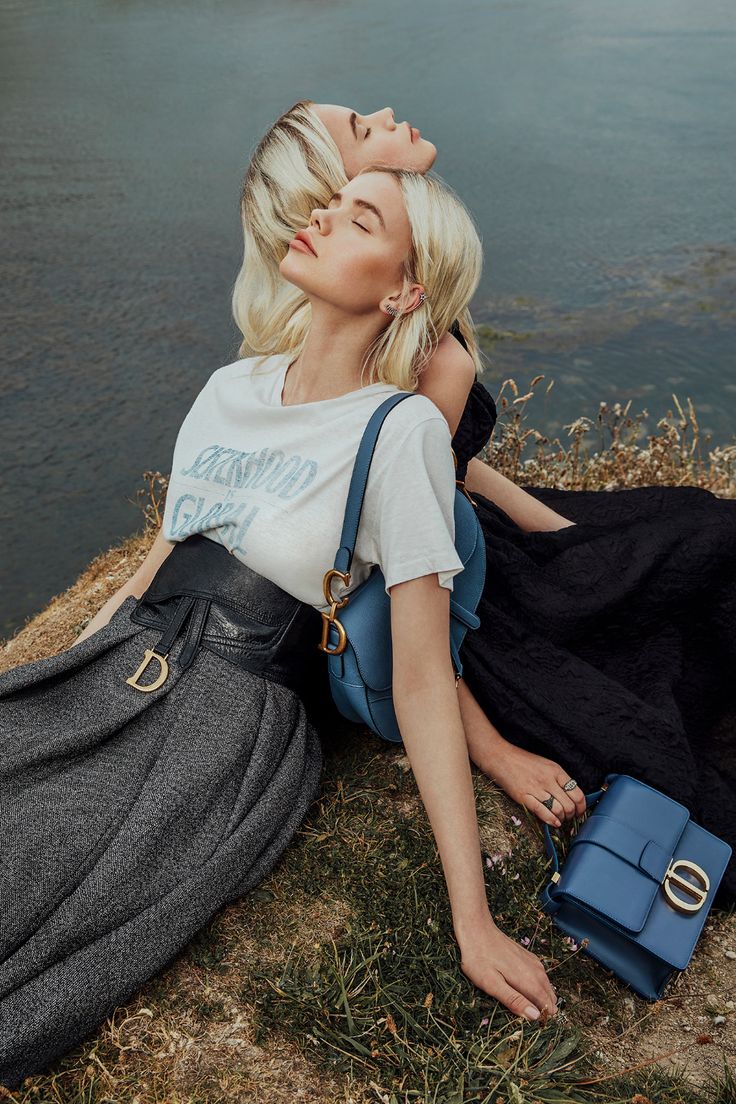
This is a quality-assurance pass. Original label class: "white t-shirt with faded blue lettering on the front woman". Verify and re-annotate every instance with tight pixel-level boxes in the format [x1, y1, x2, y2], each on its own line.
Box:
[163, 353, 462, 611]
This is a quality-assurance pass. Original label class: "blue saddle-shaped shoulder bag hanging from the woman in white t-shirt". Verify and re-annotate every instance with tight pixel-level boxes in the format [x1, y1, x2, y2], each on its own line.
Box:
[318, 391, 486, 743]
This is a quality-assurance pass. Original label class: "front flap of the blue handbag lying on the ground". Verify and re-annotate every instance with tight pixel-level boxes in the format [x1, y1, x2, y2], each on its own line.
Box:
[554, 775, 690, 932]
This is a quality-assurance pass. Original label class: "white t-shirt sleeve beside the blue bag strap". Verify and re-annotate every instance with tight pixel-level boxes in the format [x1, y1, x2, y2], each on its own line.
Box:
[361, 416, 463, 594]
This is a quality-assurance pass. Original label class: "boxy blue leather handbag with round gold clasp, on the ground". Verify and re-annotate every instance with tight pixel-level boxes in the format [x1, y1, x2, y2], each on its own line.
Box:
[540, 774, 733, 1000]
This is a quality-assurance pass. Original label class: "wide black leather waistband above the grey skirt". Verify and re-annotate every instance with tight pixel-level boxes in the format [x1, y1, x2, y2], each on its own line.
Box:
[130, 533, 322, 694]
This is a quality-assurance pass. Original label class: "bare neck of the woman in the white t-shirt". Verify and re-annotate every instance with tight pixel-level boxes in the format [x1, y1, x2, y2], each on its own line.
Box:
[284, 300, 383, 404]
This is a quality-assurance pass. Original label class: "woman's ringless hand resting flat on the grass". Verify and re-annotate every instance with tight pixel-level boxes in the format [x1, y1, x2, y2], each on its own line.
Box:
[456, 914, 557, 1020]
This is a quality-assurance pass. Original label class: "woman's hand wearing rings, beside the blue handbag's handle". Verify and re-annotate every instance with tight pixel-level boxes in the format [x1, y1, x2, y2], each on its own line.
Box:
[486, 740, 586, 827]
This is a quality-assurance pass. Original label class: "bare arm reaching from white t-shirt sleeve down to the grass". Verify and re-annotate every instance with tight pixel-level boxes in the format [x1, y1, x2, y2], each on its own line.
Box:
[391, 573, 556, 1019]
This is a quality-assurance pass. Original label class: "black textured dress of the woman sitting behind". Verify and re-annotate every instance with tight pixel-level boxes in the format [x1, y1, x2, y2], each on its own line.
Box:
[445, 324, 736, 907]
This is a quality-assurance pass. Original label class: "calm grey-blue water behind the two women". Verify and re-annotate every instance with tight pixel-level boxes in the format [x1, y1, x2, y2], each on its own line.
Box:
[0, 0, 736, 635]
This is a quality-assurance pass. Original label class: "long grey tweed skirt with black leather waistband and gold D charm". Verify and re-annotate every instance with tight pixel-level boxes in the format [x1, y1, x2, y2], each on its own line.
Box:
[0, 534, 322, 1089]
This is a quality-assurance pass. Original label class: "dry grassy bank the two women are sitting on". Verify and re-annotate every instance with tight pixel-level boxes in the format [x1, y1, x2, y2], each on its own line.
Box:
[0, 376, 736, 1104]
